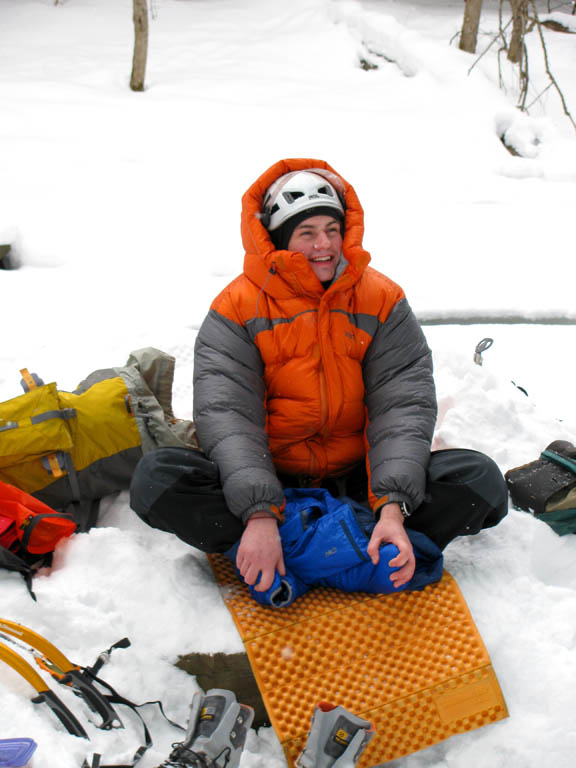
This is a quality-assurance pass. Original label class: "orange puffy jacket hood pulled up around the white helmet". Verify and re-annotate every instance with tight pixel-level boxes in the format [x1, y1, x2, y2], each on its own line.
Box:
[241, 158, 370, 298]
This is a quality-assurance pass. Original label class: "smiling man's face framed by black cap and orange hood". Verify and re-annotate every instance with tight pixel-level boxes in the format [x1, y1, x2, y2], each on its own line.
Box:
[287, 216, 342, 283]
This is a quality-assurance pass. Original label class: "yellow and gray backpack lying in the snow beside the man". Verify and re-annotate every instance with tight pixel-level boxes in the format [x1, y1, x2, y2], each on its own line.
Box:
[0, 348, 198, 531]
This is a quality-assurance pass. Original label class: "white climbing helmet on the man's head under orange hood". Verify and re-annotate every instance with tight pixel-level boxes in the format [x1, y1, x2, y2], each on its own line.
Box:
[262, 171, 344, 232]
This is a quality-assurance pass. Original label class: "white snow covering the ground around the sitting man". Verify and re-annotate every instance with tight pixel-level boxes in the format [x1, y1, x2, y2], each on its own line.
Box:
[0, 0, 576, 768]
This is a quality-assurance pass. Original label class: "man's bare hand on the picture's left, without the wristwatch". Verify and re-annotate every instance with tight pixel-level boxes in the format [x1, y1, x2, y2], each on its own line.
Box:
[236, 512, 286, 592]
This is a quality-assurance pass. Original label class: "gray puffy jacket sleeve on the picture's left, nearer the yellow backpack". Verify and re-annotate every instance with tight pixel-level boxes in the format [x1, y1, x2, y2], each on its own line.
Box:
[194, 310, 284, 522]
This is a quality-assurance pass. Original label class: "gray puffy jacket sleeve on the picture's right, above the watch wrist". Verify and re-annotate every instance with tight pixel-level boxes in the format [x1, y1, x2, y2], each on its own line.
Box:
[364, 299, 437, 509]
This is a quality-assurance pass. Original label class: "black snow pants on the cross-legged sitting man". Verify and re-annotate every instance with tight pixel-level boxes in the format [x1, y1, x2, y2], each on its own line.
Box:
[130, 448, 508, 552]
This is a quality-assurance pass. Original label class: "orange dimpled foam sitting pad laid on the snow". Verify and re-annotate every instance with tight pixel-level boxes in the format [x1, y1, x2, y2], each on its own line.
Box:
[209, 555, 508, 768]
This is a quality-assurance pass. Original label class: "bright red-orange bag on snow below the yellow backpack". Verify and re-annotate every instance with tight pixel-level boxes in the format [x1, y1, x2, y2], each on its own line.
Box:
[0, 481, 76, 555]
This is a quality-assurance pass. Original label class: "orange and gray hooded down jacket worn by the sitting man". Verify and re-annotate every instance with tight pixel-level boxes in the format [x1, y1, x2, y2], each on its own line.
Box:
[194, 159, 436, 521]
